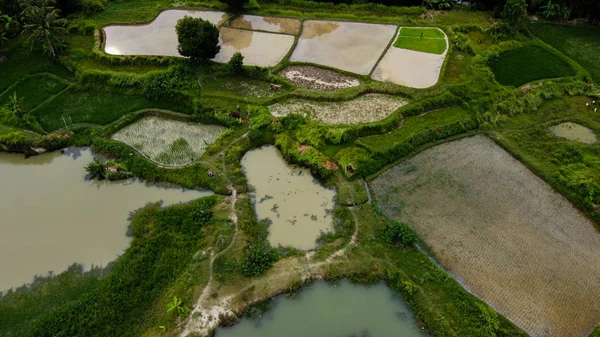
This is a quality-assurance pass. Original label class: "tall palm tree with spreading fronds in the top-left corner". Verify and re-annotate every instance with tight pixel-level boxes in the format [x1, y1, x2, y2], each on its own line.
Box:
[21, 0, 67, 57]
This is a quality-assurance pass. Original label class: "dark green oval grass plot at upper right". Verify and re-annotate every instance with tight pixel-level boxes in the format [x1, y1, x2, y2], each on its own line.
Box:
[492, 45, 575, 87]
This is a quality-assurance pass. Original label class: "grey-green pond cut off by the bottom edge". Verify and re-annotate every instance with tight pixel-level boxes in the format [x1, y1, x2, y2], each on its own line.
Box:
[216, 280, 426, 337]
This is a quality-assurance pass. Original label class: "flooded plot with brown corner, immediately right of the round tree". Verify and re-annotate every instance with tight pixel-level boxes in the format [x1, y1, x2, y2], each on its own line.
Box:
[213, 27, 294, 67]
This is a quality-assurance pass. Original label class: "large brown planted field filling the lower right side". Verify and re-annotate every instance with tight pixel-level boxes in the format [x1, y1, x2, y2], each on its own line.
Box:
[372, 136, 600, 337]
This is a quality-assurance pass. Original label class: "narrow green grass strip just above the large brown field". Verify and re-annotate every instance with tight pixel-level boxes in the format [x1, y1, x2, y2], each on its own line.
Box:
[358, 106, 470, 152]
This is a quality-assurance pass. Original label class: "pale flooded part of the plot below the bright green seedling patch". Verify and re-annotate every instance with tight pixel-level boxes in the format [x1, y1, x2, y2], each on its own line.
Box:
[371, 28, 448, 89]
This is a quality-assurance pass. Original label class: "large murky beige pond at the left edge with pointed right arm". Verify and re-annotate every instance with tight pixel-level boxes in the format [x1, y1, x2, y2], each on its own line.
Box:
[0, 149, 210, 291]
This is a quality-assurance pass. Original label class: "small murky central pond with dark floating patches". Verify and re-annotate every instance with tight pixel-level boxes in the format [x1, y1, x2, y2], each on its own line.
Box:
[242, 146, 335, 250]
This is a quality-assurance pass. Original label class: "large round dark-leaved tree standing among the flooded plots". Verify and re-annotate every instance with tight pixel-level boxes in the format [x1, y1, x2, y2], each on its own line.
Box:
[175, 16, 221, 61]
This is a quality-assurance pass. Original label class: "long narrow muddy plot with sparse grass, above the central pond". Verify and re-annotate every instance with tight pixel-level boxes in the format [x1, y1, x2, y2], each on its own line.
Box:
[269, 94, 407, 124]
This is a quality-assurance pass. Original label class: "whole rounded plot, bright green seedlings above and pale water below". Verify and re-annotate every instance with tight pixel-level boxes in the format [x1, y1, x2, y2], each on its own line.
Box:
[371, 28, 448, 89]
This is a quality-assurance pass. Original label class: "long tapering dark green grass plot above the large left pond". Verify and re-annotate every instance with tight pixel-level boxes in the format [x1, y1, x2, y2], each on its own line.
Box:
[32, 89, 190, 131]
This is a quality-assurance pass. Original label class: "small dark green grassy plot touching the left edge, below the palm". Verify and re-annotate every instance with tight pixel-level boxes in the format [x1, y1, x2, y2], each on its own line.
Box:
[0, 73, 67, 111]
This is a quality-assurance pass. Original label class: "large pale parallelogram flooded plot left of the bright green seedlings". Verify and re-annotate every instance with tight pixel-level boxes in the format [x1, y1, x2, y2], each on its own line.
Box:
[290, 20, 396, 75]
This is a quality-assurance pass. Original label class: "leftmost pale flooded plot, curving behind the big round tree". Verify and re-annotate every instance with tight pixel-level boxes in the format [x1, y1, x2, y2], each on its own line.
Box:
[104, 9, 227, 56]
